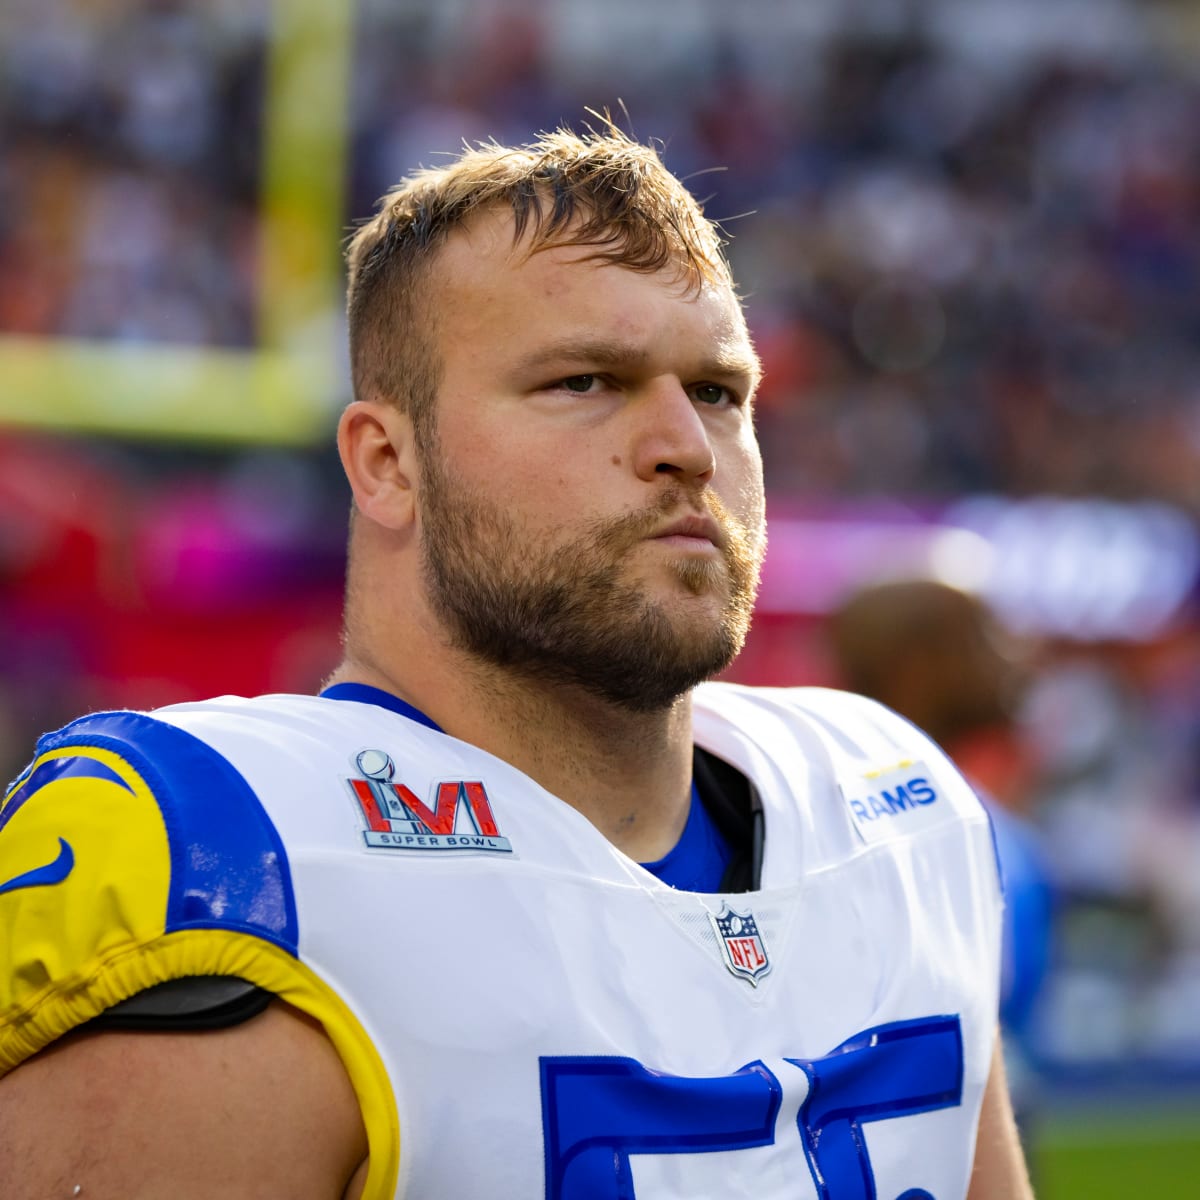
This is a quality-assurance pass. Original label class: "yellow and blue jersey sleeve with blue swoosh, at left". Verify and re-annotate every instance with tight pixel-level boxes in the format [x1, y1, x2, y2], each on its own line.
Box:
[0, 713, 298, 1074]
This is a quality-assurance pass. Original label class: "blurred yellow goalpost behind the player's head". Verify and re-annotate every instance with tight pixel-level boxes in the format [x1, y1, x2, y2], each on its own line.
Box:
[0, 0, 354, 445]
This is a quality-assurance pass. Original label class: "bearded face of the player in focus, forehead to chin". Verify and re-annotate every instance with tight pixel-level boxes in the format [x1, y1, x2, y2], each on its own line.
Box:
[420, 215, 764, 712]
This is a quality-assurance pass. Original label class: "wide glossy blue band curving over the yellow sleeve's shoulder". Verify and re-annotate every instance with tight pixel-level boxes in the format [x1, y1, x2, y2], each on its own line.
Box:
[33, 713, 299, 956]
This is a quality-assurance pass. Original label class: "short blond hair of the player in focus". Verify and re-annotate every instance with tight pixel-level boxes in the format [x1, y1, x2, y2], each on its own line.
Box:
[347, 119, 732, 438]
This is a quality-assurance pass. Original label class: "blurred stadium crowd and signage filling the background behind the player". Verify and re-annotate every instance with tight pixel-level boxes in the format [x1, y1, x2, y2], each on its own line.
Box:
[0, 0, 1200, 1180]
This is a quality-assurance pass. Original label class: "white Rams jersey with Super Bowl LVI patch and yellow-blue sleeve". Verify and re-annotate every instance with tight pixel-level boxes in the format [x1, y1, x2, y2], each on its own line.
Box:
[0, 684, 1001, 1200]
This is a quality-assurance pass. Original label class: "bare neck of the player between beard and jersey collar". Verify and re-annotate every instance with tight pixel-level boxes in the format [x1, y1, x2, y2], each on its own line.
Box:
[329, 656, 692, 862]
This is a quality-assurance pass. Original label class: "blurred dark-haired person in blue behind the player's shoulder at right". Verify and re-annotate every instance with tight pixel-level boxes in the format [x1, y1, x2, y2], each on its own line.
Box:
[829, 580, 1055, 1099]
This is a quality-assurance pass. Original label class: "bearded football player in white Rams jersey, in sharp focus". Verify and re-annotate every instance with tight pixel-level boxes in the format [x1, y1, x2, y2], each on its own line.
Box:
[0, 126, 1031, 1200]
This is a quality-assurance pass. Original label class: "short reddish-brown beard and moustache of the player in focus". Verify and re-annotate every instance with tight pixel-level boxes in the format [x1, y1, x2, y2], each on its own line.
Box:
[421, 451, 762, 712]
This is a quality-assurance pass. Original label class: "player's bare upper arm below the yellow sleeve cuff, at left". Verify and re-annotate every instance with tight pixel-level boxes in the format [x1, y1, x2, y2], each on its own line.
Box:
[0, 1002, 366, 1200]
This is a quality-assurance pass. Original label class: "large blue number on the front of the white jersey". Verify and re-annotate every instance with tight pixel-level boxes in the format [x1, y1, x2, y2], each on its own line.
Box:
[541, 1016, 962, 1200]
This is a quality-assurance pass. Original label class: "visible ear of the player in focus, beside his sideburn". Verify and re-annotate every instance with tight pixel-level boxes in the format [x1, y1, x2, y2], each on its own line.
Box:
[337, 400, 416, 529]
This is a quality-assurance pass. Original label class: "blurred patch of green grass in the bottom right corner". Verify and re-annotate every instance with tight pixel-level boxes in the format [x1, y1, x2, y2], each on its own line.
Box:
[1030, 1111, 1200, 1200]
